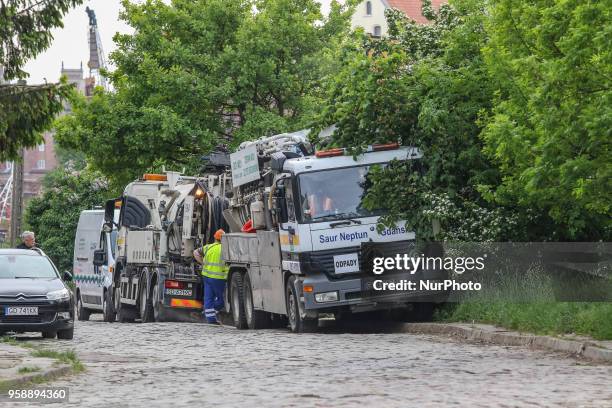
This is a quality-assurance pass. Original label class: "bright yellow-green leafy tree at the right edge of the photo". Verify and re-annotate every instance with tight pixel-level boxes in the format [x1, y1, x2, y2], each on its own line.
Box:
[482, 0, 612, 239]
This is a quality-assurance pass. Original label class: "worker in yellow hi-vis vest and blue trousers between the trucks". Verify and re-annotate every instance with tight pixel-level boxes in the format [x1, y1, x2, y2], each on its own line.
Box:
[193, 229, 229, 324]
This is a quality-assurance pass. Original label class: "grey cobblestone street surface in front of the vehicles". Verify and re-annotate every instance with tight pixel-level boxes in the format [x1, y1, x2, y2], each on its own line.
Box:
[4, 321, 612, 407]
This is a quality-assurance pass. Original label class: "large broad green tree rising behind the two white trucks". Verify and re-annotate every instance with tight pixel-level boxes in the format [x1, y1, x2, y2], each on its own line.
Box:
[56, 0, 349, 184]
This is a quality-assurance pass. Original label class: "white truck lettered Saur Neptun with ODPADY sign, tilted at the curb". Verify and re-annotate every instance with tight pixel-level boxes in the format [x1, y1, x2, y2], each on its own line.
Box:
[222, 131, 442, 332]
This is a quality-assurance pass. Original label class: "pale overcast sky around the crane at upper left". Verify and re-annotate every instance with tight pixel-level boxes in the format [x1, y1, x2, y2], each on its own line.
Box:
[25, 0, 331, 84]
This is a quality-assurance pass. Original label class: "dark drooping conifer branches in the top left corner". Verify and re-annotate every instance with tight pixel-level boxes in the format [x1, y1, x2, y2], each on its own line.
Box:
[0, 0, 83, 160]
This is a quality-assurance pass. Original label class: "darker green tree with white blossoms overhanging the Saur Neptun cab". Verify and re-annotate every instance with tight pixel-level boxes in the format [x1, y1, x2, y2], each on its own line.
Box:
[321, 0, 518, 240]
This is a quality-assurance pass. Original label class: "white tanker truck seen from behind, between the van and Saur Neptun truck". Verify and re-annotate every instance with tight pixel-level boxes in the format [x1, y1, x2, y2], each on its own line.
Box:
[105, 172, 227, 322]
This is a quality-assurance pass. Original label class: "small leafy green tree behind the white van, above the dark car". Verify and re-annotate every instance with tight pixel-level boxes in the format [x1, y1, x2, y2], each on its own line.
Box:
[25, 168, 113, 271]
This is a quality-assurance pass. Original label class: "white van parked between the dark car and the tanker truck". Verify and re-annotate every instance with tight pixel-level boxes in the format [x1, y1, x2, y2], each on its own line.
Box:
[72, 209, 117, 322]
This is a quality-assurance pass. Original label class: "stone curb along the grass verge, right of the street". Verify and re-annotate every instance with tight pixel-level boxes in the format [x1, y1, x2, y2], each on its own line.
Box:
[400, 323, 612, 363]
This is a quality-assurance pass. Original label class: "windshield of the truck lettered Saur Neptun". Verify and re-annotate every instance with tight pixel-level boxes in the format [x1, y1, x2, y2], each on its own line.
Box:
[298, 166, 383, 223]
